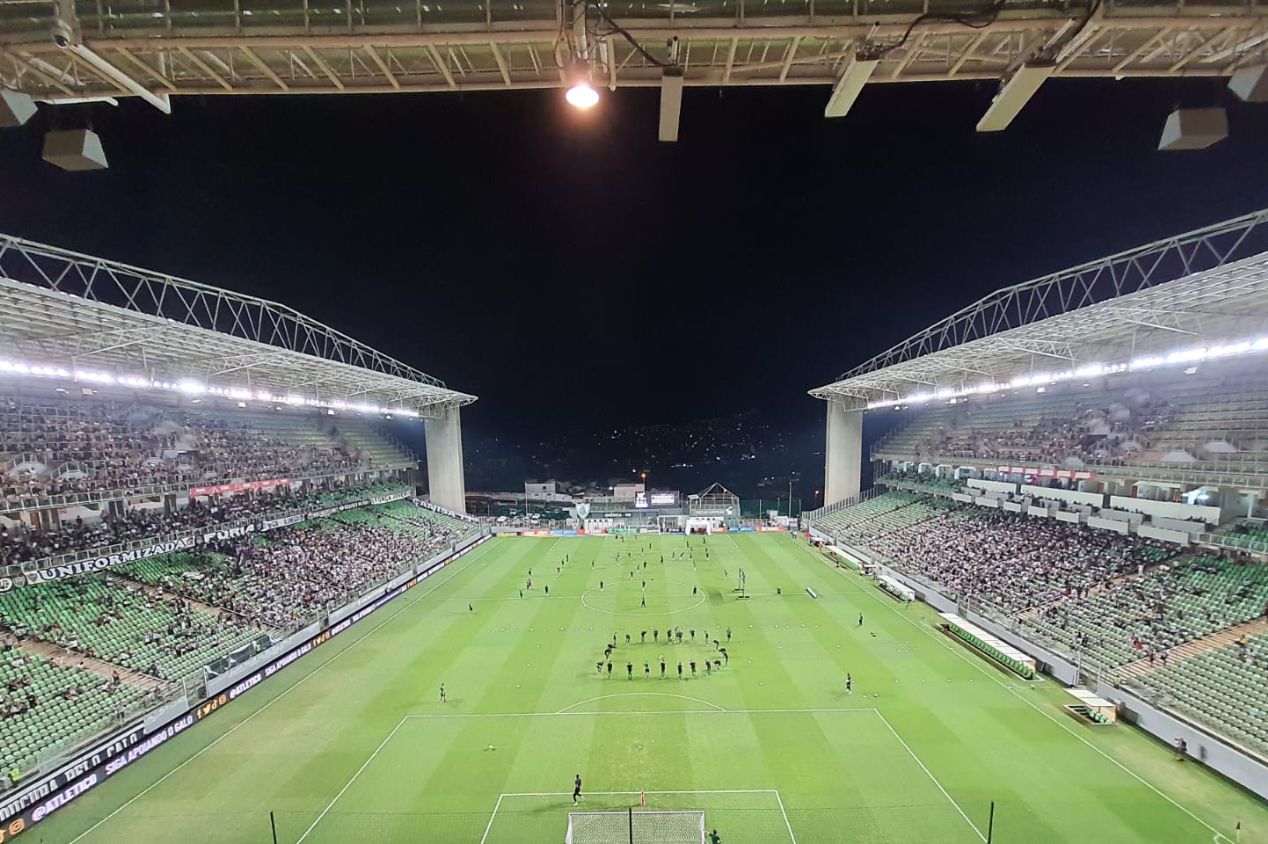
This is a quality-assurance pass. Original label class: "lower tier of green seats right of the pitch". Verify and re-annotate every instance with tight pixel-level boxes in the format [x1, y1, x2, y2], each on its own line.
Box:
[815, 486, 1268, 754]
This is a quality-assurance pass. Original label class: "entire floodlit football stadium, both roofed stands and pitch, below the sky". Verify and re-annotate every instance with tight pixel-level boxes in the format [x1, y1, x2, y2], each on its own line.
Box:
[0, 205, 1268, 844]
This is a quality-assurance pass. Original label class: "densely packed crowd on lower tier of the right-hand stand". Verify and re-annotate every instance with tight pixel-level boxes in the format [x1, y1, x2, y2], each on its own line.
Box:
[869, 507, 1173, 613]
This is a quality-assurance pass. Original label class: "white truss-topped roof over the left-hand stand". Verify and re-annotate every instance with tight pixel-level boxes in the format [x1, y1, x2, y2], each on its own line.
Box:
[0, 234, 476, 416]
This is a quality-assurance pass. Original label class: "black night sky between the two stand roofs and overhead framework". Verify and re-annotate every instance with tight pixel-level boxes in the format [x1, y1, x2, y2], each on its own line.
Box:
[0, 73, 1268, 473]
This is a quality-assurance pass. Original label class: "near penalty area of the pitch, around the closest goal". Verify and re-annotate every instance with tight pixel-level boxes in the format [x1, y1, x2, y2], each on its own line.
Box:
[292, 696, 985, 844]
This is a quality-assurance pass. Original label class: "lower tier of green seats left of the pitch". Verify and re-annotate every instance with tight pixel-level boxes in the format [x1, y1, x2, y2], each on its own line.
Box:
[0, 494, 479, 769]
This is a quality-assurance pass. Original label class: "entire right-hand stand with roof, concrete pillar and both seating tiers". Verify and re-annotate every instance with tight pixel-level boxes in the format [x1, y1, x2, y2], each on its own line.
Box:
[803, 204, 1268, 795]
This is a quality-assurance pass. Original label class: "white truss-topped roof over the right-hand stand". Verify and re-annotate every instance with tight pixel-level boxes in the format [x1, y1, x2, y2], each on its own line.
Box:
[810, 209, 1268, 407]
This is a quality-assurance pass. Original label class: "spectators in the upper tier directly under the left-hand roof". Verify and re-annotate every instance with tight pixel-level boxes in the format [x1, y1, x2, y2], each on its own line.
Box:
[0, 397, 366, 506]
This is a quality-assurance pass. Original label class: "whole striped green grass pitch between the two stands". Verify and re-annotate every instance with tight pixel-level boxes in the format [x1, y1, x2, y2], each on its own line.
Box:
[34, 534, 1268, 844]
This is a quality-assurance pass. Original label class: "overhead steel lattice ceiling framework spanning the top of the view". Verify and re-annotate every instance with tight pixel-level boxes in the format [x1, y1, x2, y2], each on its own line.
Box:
[0, 0, 1268, 131]
